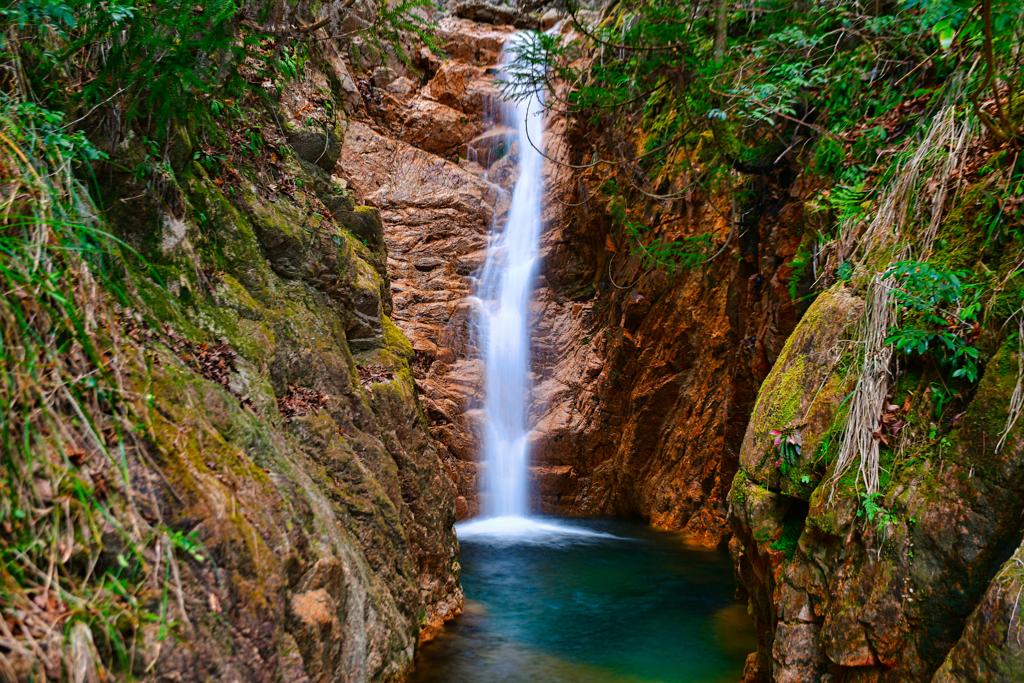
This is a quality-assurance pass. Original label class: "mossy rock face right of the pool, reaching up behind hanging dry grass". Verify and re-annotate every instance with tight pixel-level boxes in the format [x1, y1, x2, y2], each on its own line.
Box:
[729, 126, 1024, 682]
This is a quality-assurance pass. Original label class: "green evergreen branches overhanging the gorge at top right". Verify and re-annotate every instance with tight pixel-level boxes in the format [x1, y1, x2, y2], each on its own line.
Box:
[503, 0, 1024, 276]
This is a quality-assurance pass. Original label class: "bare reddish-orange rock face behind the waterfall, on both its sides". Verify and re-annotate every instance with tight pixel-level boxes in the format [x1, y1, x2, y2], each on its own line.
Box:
[358, 19, 804, 544]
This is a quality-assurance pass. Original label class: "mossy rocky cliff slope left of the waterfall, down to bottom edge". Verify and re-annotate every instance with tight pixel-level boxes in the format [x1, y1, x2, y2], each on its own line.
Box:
[0, 21, 464, 683]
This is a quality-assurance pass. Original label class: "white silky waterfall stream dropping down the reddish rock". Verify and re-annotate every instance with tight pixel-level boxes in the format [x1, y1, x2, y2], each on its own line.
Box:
[459, 34, 601, 540]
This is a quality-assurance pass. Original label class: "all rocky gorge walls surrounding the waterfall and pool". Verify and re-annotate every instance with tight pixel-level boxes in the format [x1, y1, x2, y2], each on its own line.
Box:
[8, 3, 1024, 683]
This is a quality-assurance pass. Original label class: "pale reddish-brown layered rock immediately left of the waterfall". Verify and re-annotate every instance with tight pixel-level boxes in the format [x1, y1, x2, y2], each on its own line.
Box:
[338, 18, 516, 519]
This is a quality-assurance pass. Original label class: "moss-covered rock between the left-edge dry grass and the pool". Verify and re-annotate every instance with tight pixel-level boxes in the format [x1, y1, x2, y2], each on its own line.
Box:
[74, 87, 462, 681]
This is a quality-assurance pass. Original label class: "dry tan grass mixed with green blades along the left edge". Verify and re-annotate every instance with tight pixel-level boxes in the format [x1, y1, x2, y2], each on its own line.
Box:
[0, 100, 190, 680]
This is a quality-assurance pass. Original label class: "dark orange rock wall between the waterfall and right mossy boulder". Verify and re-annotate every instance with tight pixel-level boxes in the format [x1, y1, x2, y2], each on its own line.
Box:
[532, 105, 806, 545]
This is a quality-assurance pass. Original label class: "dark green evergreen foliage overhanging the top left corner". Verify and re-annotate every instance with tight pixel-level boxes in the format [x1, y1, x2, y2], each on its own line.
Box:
[0, 0, 435, 139]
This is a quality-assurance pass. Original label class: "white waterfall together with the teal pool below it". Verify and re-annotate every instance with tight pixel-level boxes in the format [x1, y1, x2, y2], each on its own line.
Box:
[413, 31, 757, 683]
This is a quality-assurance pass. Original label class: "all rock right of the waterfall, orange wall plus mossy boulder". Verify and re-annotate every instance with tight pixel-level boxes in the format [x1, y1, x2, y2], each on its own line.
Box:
[466, 31, 1024, 682]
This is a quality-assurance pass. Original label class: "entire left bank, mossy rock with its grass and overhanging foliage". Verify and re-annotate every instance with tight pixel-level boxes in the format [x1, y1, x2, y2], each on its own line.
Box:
[0, 0, 461, 681]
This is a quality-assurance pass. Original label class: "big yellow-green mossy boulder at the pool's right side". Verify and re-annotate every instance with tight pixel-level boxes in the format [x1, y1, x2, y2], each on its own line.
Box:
[731, 286, 1024, 681]
